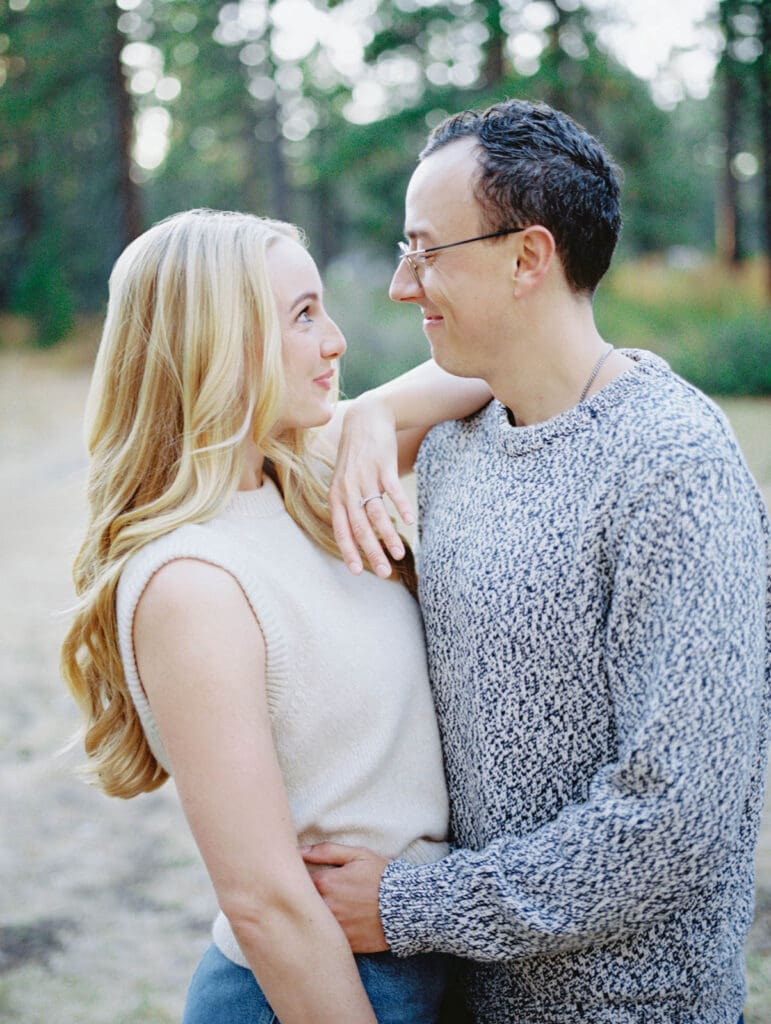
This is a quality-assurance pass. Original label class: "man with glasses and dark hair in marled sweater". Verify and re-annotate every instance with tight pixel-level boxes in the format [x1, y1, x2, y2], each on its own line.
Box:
[306, 100, 771, 1024]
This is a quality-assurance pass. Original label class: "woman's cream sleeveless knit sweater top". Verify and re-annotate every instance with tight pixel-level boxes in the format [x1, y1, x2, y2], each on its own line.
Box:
[117, 479, 447, 967]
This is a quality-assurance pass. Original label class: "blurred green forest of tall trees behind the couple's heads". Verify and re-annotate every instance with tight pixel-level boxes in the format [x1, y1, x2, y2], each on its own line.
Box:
[0, 0, 771, 395]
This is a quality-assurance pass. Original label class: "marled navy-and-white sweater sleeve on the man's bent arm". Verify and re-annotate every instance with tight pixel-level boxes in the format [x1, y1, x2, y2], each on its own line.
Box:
[380, 461, 769, 961]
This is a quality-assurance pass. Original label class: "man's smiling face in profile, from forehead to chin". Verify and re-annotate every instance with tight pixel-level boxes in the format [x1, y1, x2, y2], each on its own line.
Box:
[389, 138, 518, 379]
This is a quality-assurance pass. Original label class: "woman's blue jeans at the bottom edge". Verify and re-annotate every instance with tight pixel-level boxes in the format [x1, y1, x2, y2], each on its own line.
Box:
[182, 945, 447, 1024]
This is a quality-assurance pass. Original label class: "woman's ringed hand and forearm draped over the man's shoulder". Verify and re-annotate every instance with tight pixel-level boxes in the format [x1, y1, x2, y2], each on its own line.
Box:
[328, 359, 492, 575]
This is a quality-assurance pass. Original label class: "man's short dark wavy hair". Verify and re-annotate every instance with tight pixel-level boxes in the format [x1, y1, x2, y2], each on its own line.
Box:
[420, 99, 622, 295]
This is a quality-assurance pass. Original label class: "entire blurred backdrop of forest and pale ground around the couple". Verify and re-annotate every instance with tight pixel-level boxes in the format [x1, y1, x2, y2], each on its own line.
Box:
[0, 0, 771, 1024]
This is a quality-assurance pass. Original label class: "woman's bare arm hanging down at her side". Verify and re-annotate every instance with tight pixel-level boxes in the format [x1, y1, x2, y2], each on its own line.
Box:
[134, 559, 376, 1024]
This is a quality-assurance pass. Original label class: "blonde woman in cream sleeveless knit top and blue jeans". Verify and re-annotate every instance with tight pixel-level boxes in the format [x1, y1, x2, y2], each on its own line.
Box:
[62, 210, 488, 1024]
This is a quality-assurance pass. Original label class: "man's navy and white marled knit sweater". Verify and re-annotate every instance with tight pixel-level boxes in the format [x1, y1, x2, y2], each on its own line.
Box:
[380, 352, 771, 1024]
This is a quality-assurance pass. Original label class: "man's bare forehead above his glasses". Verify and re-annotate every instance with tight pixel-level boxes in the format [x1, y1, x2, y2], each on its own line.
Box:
[404, 138, 479, 236]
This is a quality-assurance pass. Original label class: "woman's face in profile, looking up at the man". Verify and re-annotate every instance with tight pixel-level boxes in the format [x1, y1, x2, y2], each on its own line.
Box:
[268, 238, 345, 433]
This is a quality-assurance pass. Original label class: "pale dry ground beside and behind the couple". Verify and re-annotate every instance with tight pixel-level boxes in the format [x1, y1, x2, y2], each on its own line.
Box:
[0, 350, 771, 1024]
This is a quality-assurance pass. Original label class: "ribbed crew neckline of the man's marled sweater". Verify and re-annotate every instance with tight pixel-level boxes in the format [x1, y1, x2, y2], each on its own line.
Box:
[491, 348, 668, 456]
